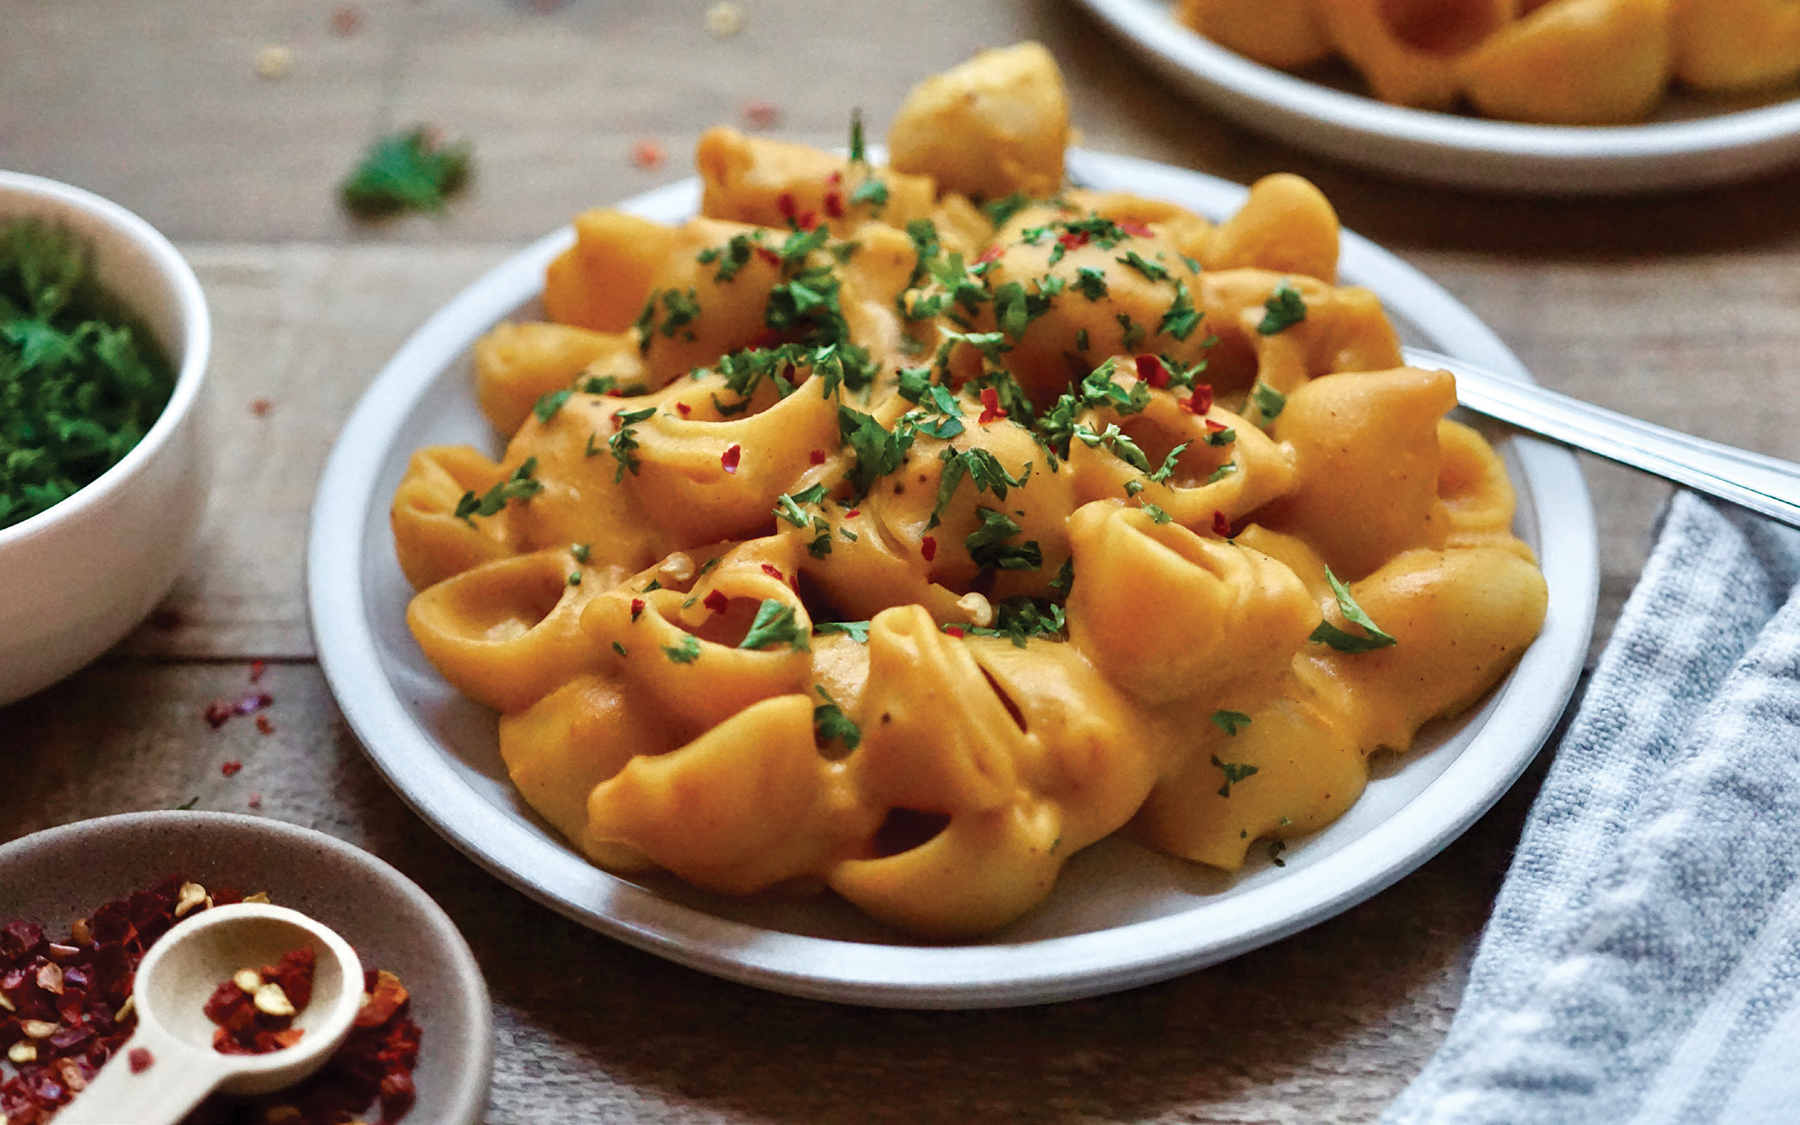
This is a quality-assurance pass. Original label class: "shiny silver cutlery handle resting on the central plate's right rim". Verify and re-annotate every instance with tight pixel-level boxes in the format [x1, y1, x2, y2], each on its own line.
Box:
[1406, 347, 1800, 527]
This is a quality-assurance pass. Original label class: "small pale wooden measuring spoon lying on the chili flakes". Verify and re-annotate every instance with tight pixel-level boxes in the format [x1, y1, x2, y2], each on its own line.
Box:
[56, 904, 362, 1125]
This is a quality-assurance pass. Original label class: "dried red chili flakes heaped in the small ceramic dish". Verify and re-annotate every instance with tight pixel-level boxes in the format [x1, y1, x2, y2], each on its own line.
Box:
[0, 875, 419, 1125]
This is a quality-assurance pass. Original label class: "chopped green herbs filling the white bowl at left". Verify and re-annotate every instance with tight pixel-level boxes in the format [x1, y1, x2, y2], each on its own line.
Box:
[0, 220, 175, 527]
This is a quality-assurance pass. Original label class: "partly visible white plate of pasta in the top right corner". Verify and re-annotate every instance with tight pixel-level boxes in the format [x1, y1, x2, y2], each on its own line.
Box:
[1080, 0, 1800, 194]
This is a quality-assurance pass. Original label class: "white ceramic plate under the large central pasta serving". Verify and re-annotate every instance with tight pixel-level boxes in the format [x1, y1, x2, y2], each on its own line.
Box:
[308, 153, 1598, 1008]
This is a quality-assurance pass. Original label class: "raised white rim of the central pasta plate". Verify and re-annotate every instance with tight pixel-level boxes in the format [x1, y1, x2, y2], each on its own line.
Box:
[306, 149, 1598, 1008]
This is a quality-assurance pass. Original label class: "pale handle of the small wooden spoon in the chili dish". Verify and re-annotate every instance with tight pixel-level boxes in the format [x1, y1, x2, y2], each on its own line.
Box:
[56, 1022, 229, 1125]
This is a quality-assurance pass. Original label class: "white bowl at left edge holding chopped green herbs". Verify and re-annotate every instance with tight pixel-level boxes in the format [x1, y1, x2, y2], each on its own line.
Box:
[0, 171, 212, 706]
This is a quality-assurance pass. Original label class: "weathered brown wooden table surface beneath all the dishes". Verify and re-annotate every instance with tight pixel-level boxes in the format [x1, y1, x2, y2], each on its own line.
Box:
[0, 0, 1800, 1123]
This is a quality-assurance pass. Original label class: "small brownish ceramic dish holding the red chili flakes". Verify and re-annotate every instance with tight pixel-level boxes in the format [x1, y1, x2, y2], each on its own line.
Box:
[0, 812, 493, 1125]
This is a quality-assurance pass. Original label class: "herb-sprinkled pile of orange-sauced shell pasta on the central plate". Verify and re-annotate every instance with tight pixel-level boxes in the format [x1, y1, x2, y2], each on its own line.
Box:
[392, 43, 1546, 940]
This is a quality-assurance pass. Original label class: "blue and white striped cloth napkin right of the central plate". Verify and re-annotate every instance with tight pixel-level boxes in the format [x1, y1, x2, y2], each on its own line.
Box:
[1382, 493, 1800, 1125]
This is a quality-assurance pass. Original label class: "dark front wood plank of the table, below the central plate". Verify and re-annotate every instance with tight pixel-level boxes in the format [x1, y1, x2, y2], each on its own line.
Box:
[0, 659, 1562, 1125]
